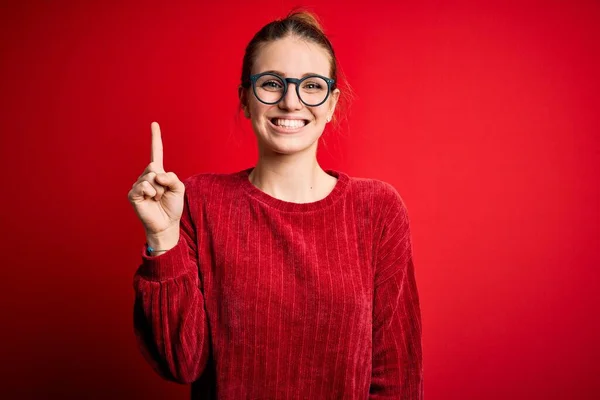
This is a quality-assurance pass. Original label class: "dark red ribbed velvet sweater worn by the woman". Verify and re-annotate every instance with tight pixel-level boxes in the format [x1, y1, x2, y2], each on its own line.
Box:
[134, 169, 423, 400]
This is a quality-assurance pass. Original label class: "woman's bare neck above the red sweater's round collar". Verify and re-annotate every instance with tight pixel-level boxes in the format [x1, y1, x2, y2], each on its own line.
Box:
[249, 146, 337, 203]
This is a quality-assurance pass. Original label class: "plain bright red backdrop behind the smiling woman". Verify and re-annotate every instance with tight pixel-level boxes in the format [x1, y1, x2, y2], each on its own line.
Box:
[0, 0, 600, 399]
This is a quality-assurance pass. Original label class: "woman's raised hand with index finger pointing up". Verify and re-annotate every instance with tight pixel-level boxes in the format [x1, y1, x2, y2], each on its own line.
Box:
[128, 122, 185, 249]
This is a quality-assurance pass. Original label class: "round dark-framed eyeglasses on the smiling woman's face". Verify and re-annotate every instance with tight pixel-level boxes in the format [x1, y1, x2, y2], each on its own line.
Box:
[250, 72, 335, 107]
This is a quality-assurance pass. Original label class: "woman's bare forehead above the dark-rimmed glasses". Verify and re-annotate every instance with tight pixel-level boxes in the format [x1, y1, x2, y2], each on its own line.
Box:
[251, 37, 331, 77]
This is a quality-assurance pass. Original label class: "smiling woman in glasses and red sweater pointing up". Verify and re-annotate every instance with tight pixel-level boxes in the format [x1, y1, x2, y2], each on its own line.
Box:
[129, 12, 423, 399]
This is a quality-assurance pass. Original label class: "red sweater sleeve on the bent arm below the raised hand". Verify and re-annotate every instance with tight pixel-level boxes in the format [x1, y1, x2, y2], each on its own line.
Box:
[133, 191, 210, 383]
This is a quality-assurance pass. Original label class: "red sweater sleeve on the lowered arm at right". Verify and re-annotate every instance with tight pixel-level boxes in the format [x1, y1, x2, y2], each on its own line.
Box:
[369, 185, 423, 400]
